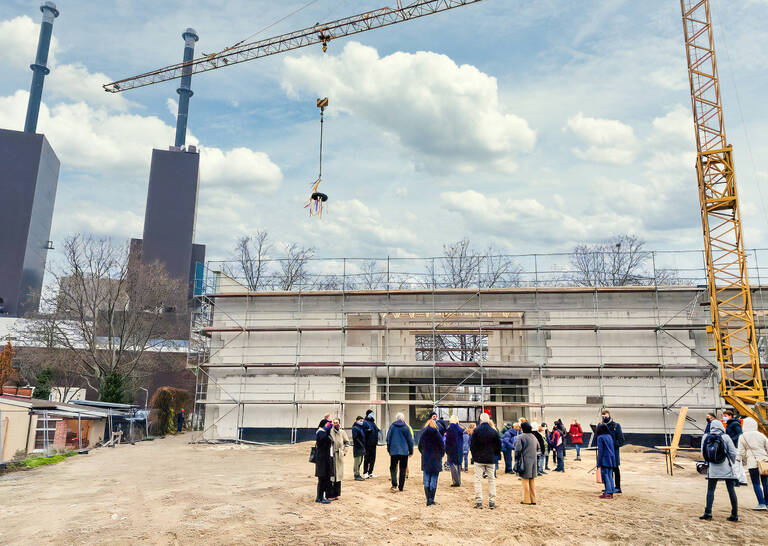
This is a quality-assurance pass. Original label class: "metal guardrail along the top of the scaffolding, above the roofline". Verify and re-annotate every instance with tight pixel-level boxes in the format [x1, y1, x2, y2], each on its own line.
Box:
[206, 249, 768, 292]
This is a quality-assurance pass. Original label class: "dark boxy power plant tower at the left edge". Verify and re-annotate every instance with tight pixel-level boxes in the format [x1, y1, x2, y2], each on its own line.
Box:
[0, 129, 60, 316]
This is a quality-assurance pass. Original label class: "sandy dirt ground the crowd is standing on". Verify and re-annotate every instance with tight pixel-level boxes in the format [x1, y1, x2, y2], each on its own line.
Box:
[0, 434, 768, 545]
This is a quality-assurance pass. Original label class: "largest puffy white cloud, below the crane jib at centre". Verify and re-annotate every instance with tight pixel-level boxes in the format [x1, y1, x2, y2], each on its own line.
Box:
[283, 42, 536, 173]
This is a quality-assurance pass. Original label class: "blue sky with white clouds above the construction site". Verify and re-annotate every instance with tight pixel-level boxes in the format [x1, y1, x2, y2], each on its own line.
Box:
[0, 0, 768, 268]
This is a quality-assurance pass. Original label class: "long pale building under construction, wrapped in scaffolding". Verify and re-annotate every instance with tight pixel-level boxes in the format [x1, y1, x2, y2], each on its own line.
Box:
[190, 253, 765, 442]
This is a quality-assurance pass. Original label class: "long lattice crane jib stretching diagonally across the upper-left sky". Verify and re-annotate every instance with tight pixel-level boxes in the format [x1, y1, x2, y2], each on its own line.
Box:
[103, 0, 481, 93]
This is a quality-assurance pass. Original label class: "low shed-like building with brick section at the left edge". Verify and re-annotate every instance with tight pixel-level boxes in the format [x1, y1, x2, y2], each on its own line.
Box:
[0, 395, 108, 462]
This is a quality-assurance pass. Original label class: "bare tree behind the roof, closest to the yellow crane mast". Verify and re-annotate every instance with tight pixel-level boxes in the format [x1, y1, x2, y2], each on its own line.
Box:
[570, 234, 677, 286]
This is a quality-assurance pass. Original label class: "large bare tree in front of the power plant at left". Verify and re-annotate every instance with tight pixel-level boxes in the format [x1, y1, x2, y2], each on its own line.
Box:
[33, 235, 186, 401]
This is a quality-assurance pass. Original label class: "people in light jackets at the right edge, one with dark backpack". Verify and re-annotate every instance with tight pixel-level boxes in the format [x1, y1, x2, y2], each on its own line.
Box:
[700, 410, 768, 521]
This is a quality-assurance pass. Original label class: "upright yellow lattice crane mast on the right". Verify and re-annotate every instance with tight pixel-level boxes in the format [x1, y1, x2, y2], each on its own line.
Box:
[680, 0, 768, 430]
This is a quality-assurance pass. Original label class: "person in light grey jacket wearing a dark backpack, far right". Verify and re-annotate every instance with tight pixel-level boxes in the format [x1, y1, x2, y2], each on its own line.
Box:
[699, 420, 739, 521]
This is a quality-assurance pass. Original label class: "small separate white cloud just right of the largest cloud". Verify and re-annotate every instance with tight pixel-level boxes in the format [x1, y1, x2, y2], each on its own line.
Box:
[566, 112, 637, 165]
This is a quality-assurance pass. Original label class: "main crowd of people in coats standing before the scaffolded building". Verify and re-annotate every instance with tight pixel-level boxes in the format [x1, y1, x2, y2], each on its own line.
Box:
[313, 410, 624, 510]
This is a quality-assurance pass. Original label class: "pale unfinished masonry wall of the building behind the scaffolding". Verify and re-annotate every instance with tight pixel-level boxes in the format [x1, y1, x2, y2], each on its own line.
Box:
[205, 285, 723, 438]
